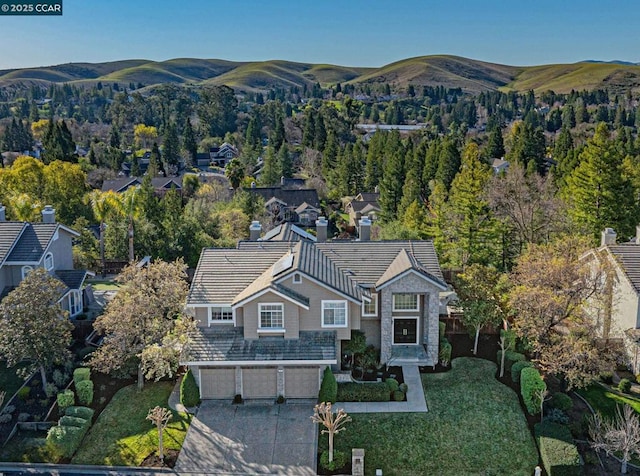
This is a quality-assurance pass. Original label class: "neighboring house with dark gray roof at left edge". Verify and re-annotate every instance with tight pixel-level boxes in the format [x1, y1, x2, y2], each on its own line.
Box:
[0, 205, 88, 318]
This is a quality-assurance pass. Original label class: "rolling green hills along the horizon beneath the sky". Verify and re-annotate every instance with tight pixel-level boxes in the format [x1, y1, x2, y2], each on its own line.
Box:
[0, 55, 640, 93]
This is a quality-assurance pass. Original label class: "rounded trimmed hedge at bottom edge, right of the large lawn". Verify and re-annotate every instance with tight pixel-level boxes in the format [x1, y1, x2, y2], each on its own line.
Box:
[535, 421, 582, 476]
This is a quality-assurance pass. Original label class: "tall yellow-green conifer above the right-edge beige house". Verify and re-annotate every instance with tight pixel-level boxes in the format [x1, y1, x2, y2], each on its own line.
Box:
[565, 123, 640, 240]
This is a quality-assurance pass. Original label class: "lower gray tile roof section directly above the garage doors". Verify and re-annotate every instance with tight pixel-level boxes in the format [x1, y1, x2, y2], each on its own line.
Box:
[186, 327, 336, 363]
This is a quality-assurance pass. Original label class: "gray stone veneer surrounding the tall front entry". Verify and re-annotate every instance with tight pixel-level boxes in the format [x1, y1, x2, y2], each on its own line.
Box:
[379, 273, 440, 362]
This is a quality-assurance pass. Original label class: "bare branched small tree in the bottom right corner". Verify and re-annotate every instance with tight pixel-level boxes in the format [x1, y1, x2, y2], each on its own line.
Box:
[589, 405, 640, 474]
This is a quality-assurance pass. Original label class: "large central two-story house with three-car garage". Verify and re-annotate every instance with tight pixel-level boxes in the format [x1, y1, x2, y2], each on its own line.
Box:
[182, 219, 447, 399]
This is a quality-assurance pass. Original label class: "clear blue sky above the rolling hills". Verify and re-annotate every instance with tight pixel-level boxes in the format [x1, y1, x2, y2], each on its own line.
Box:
[0, 0, 640, 69]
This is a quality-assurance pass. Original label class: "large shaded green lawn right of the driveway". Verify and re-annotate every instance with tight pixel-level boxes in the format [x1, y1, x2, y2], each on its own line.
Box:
[319, 358, 538, 476]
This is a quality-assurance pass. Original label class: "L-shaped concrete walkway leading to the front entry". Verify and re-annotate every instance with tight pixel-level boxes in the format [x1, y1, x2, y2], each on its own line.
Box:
[333, 365, 427, 413]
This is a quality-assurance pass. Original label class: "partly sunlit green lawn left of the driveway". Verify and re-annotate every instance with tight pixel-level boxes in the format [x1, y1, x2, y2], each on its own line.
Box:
[72, 382, 191, 466]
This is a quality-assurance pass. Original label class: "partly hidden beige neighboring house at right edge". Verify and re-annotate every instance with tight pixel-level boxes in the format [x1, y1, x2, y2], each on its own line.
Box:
[583, 227, 640, 374]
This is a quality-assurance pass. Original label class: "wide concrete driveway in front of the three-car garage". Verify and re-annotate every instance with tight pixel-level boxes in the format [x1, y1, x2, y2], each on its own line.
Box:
[175, 400, 318, 475]
